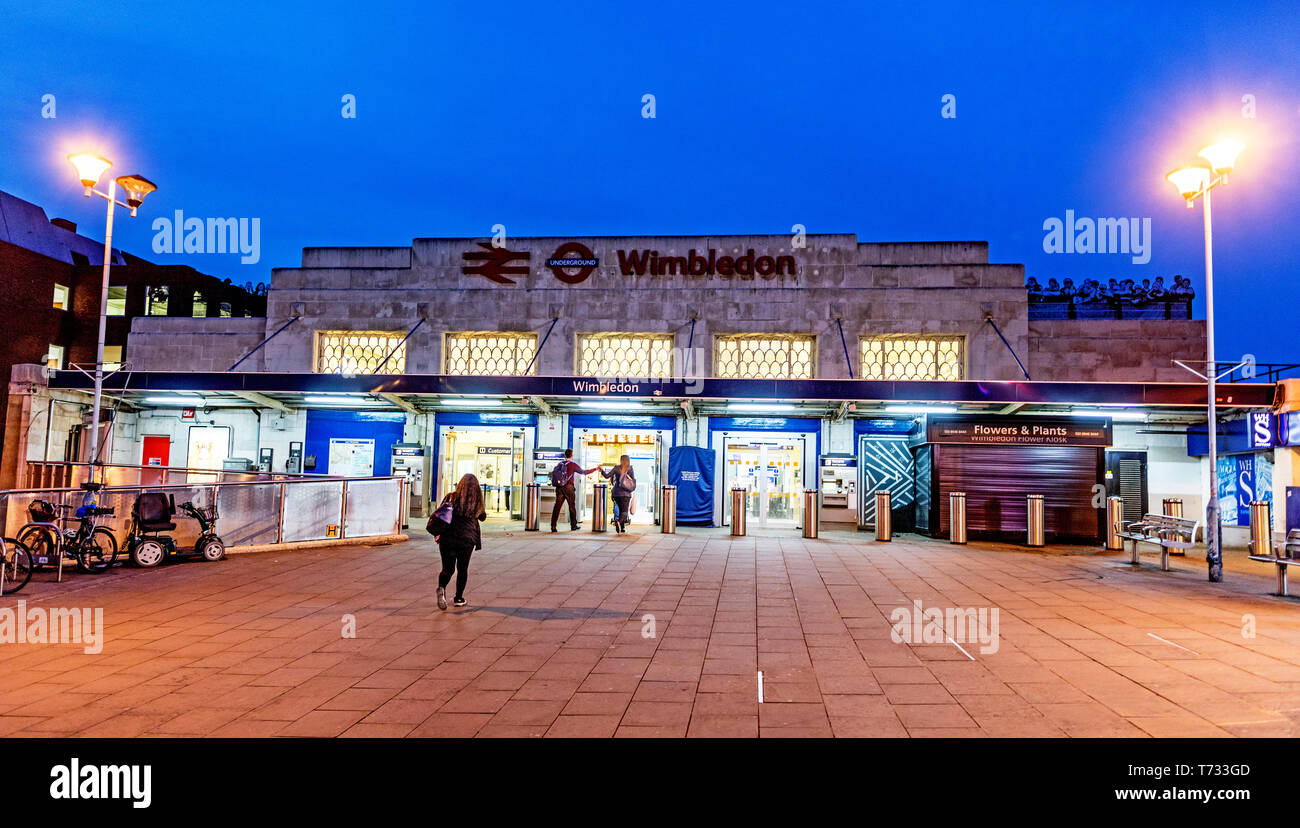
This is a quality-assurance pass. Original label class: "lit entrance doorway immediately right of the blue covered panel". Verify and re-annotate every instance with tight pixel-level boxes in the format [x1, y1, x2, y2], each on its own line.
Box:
[723, 437, 805, 526]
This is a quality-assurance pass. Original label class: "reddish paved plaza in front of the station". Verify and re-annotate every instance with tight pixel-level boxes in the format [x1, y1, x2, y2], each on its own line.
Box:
[0, 524, 1300, 737]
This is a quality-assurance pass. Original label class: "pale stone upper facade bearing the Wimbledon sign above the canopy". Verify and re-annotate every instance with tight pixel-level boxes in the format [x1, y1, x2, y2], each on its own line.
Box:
[130, 234, 1204, 380]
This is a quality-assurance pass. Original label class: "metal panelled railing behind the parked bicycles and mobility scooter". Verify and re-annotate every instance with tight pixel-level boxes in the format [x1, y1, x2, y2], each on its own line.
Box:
[0, 475, 407, 549]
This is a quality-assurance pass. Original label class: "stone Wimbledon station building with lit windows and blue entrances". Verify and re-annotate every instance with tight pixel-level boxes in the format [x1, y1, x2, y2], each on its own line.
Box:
[10, 234, 1300, 541]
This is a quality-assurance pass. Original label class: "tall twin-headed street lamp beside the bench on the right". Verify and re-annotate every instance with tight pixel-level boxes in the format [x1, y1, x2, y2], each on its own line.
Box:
[1165, 140, 1245, 584]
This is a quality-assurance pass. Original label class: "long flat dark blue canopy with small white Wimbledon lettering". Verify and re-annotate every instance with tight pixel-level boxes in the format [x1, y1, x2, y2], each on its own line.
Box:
[49, 370, 1277, 422]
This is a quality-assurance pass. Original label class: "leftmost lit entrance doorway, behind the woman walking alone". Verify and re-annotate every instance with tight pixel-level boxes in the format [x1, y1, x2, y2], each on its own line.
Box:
[438, 428, 525, 520]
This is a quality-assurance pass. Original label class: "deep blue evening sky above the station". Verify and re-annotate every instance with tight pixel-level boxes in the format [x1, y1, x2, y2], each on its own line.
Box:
[0, 0, 1300, 361]
